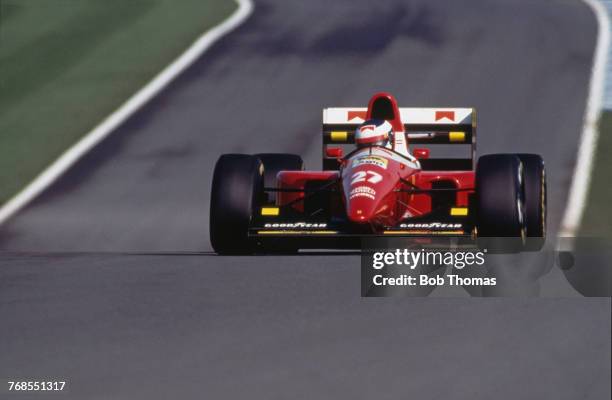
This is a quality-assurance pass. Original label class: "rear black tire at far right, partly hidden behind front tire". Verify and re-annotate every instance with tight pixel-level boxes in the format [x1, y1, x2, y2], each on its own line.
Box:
[516, 154, 546, 251]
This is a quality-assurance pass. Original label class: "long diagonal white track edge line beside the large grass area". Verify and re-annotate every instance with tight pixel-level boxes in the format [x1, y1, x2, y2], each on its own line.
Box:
[0, 0, 253, 224]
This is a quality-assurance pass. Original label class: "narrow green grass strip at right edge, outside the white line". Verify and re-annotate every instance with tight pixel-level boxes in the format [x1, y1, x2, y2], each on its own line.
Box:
[581, 111, 612, 239]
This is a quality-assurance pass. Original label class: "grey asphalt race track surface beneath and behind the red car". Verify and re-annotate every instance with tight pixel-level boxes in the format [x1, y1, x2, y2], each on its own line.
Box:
[0, 0, 610, 399]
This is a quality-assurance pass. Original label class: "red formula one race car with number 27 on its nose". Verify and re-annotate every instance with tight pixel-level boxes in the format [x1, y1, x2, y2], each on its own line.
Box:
[210, 93, 546, 254]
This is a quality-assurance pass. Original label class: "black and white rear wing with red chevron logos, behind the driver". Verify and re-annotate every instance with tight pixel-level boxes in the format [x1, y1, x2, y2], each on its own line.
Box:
[323, 107, 476, 170]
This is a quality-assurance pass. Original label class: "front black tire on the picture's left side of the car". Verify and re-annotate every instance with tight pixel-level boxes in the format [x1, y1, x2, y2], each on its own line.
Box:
[210, 154, 263, 255]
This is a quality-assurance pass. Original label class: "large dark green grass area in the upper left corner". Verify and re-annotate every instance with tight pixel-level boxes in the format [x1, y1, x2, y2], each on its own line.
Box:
[0, 0, 236, 204]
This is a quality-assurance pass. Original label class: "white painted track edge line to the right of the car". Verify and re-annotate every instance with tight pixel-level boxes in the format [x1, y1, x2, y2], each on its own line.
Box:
[559, 0, 610, 242]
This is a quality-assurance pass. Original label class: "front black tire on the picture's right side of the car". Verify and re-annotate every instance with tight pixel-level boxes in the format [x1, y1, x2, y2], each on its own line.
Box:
[475, 154, 526, 253]
